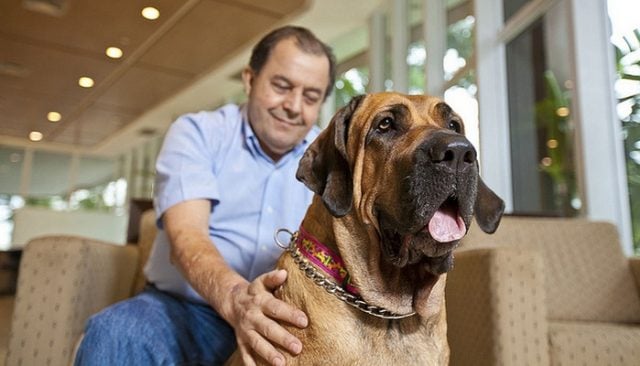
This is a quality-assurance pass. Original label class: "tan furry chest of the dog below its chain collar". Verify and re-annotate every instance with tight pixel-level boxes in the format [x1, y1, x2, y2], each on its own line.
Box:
[277, 253, 449, 366]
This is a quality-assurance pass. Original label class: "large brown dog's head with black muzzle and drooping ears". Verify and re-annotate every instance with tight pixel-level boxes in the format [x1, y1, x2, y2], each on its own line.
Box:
[297, 93, 504, 310]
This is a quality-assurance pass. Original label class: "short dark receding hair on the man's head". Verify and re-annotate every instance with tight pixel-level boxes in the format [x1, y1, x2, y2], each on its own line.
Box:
[249, 25, 336, 99]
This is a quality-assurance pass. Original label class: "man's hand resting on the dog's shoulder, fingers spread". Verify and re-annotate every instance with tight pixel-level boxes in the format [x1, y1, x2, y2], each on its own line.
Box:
[224, 270, 308, 366]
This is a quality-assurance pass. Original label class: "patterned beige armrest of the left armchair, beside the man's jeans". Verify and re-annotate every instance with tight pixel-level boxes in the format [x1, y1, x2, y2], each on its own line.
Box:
[7, 236, 138, 365]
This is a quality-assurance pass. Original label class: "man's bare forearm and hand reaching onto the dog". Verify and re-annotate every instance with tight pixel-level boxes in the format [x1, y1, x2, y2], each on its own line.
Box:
[163, 200, 308, 365]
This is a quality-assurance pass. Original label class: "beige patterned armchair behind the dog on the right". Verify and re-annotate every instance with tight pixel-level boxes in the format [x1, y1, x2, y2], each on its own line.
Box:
[446, 217, 640, 366]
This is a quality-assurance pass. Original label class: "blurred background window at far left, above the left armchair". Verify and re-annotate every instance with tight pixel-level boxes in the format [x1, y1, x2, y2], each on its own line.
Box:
[0, 146, 127, 250]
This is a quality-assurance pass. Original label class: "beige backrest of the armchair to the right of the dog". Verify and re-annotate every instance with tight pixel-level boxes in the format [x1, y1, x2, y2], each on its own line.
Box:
[461, 217, 640, 323]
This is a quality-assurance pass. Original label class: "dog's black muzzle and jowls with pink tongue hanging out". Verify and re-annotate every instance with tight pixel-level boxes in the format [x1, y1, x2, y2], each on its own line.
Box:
[381, 130, 478, 274]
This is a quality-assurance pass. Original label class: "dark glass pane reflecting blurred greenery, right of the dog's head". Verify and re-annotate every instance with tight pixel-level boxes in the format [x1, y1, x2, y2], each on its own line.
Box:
[506, 9, 582, 216]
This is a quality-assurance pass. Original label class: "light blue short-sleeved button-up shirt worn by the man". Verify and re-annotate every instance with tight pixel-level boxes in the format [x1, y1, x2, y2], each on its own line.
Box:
[145, 105, 318, 302]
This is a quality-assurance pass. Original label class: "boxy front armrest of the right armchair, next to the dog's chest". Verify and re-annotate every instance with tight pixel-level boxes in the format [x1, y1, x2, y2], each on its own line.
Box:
[446, 247, 549, 366]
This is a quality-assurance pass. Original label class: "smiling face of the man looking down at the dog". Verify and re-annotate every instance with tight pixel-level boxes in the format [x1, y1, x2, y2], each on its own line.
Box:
[242, 38, 329, 161]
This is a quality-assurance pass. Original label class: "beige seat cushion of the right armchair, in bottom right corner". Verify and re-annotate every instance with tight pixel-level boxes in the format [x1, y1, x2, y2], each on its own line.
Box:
[549, 322, 640, 366]
